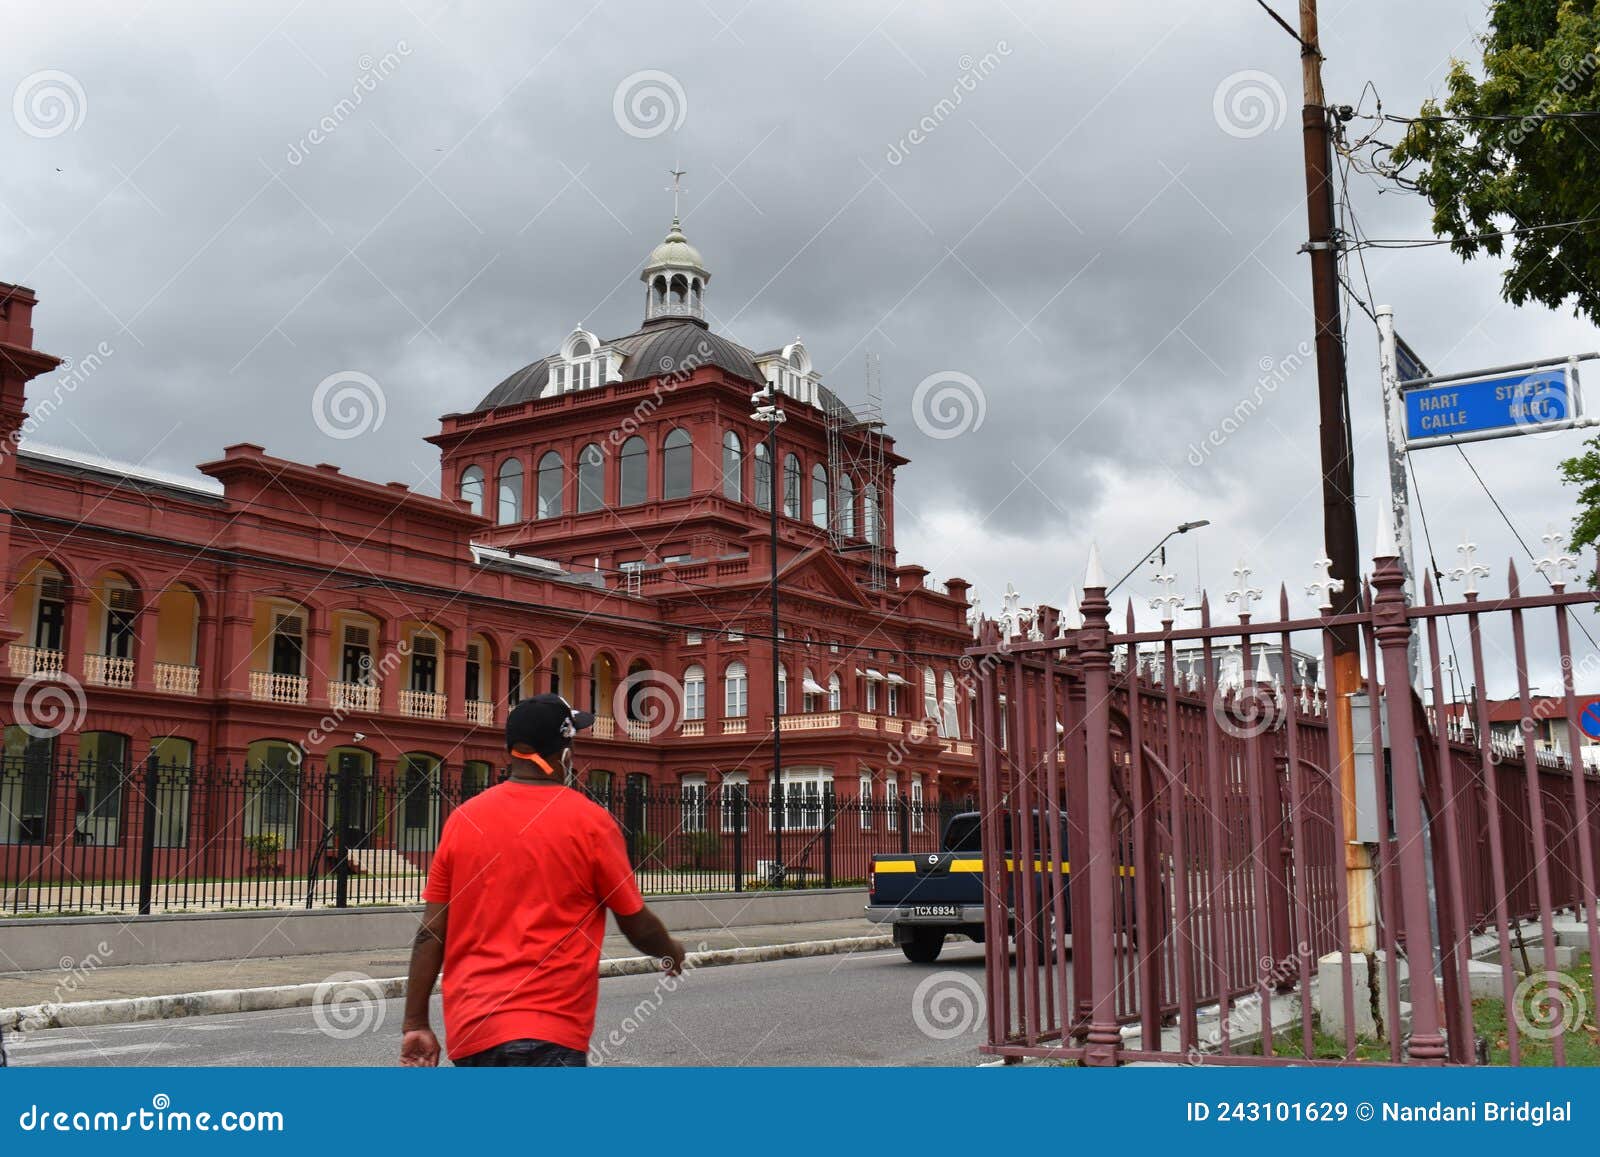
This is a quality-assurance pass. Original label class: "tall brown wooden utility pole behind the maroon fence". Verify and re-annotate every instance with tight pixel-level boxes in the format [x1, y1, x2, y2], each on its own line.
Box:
[1299, 0, 1379, 952]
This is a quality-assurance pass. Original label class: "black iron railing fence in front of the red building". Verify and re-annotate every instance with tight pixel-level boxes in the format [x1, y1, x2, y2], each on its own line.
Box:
[0, 755, 965, 915]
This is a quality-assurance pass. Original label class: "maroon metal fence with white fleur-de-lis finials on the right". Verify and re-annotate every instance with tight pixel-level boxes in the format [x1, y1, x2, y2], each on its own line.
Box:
[968, 544, 1600, 1064]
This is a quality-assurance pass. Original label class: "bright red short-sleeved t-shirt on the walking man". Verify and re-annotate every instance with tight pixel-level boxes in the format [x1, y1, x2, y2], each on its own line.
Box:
[422, 779, 645, 1058]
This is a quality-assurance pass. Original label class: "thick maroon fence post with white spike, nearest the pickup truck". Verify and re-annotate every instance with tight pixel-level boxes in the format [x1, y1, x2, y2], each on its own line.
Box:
[1072, 544, 1122, 1066]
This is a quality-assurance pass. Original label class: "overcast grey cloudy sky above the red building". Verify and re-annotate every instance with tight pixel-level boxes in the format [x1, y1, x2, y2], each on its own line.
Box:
[0, 0, 1600, 688]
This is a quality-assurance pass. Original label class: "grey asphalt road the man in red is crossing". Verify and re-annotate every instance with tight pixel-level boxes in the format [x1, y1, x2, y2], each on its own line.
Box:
[6, 943, 982, 1066]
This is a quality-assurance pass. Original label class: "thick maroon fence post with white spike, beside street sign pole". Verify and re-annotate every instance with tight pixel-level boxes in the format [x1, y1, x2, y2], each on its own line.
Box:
[1373, 528, 1445, 1064]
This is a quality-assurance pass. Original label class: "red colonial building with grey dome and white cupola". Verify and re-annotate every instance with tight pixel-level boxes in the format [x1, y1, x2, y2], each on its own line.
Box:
[0, 222, 976, 889]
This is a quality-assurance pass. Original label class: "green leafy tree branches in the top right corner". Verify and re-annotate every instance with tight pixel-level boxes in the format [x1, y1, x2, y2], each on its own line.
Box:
[1394, 0, 1600, 320]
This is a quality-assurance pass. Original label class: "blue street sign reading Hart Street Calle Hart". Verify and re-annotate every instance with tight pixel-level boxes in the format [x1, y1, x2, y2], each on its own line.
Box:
[1403, 366, 1578, 446]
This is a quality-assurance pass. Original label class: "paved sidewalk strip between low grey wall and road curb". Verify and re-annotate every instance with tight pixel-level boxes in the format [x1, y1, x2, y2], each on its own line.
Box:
[0, 920, 890, 1010]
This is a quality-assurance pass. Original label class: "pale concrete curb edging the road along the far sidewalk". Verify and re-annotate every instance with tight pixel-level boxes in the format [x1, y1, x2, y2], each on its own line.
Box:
[0, 935, 894, 1032]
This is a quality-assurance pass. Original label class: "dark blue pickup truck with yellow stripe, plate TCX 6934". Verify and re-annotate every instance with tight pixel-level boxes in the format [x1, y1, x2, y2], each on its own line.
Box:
[867, 811, 1070, 963]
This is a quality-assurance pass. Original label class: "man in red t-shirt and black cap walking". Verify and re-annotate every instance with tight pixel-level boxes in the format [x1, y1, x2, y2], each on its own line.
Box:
[400, 695, 683, 1066]
